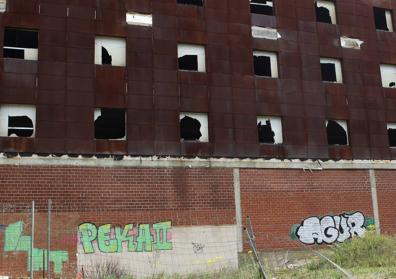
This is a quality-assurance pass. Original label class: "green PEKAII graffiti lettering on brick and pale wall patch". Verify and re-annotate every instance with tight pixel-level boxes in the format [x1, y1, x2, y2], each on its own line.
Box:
[78, 221, 173, 254]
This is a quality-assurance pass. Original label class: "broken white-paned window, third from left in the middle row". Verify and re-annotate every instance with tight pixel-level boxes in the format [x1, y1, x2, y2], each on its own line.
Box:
[177, 44, 206, 72]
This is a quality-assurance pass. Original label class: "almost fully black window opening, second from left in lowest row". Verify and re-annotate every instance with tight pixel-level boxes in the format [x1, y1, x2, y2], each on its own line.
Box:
[95, 108, 125, 139]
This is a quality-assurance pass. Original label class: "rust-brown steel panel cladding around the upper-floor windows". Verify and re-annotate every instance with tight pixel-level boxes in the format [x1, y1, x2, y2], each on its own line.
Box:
[0, 0, 396, 159]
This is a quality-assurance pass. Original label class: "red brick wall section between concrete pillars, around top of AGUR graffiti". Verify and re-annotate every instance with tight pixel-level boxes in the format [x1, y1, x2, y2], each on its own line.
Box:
[240, 169, 373, 249]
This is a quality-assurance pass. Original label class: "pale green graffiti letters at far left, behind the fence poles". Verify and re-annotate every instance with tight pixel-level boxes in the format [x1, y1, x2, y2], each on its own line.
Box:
[4, 221, 69, 273]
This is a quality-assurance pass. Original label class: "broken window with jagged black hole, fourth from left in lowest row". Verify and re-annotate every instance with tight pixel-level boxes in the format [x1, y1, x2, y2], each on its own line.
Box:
[257, 116, 283, 144]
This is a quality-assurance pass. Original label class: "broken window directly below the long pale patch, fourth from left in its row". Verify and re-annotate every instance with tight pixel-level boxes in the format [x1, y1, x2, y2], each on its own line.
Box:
[253, 51, 279, 78]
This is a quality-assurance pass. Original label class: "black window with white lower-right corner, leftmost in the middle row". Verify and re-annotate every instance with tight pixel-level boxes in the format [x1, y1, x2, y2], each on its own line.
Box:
[3, 27, 38, 60]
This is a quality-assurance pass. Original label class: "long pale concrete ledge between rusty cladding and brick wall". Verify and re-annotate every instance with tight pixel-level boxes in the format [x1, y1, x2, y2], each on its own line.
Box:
[0, 153, 396, 171]
